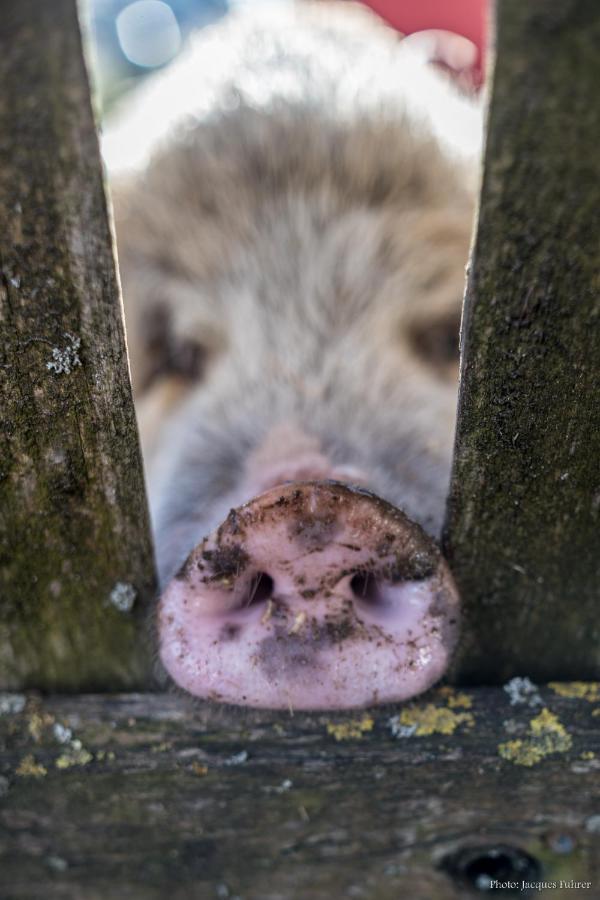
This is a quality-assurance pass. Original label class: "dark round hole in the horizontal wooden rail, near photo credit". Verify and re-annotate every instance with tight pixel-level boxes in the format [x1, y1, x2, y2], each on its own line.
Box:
[442, 844, 541, 897]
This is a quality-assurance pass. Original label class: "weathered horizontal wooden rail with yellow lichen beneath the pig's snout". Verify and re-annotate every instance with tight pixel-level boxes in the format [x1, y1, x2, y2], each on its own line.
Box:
[0, 684, 600, 900]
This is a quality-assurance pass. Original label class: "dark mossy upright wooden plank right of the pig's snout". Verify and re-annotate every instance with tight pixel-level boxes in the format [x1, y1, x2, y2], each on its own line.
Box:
[445, 0, 600, 683]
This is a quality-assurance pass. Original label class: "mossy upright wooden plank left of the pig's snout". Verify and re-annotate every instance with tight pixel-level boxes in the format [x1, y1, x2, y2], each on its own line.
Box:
[0, 0, 155, 690]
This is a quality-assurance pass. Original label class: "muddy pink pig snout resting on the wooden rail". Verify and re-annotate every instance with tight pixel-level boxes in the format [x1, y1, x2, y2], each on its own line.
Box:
[159, 481, 458, 709]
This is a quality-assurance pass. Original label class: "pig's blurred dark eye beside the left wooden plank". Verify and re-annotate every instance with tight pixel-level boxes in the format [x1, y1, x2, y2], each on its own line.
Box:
[143, 307, 206, 387]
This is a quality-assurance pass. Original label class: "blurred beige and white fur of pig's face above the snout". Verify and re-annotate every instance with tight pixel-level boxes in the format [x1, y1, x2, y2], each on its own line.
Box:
[106, 3, 479, 583]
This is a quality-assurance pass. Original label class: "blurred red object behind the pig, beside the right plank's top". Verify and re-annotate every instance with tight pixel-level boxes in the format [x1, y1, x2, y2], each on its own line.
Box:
[363, 0, 489, 86]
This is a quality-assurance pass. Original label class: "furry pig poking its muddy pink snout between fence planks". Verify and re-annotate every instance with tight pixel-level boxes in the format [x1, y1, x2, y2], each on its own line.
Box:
[104, 3, 480, 709]
